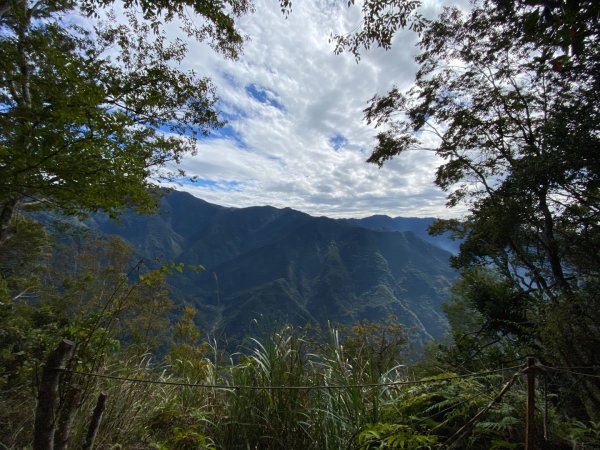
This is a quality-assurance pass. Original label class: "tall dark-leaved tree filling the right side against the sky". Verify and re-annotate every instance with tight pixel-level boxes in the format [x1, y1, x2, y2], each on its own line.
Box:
[338, 0, 600, 412]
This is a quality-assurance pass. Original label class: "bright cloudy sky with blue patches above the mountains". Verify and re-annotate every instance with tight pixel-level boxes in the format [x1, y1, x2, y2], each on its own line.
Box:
[159, 0, 457, 217]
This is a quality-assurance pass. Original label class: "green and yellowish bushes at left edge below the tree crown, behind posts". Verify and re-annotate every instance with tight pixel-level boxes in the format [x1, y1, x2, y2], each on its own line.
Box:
[0, 229, 174, 448]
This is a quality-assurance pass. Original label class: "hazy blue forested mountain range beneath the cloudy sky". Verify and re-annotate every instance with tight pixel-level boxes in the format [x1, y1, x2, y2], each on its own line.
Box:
[77, 191, 456, 340]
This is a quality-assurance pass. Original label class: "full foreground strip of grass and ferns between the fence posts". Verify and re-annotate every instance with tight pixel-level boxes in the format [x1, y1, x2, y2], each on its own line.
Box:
[2, 327, 548, 450]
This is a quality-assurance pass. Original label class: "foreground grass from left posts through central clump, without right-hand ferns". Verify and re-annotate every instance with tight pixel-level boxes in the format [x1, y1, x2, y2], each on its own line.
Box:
[57, 327, 408, 450]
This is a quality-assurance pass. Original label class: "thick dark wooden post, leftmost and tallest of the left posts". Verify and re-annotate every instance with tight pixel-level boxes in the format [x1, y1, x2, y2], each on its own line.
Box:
[33, 339, 75, 450]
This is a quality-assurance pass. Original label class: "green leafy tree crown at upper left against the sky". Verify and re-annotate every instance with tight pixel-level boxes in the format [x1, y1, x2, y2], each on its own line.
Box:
[0, 0, 251, 245]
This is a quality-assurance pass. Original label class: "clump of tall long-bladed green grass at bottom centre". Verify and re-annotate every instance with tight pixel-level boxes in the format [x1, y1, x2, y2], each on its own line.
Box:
[204, 327, 406, 449]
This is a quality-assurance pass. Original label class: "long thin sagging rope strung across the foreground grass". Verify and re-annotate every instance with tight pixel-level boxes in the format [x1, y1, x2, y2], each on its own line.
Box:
[53, 366, 520, 390]
